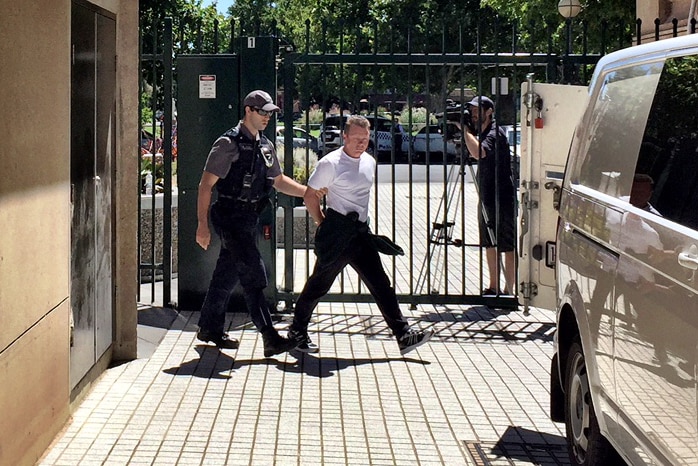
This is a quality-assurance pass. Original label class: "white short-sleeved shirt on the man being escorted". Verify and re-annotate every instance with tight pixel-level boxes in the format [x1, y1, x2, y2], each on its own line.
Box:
[308, 147, 376, 222]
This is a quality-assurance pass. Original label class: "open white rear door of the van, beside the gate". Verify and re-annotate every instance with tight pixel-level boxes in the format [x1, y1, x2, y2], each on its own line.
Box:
[519, 83, 588, 311]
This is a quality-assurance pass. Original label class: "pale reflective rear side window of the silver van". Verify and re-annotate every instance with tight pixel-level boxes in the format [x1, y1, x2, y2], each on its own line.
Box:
[571, 62, 662, 198]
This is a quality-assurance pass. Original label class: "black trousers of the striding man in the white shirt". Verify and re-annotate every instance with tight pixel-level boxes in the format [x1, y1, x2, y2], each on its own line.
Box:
[291, 233, 409, 338]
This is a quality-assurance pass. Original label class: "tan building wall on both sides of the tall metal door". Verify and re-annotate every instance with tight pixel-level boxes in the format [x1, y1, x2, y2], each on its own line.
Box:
[0, 0, 138, 465]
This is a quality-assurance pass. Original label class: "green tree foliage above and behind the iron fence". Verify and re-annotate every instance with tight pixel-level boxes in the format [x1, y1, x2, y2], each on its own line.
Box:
[141, 0, 634, 115]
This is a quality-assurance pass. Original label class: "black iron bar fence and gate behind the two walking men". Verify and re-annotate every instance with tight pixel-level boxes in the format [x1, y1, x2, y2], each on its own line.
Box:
[139, 12, 696, 305]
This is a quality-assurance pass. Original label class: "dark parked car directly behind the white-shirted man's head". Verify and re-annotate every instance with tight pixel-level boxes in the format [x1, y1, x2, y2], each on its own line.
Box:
[318, 115, 405, 161]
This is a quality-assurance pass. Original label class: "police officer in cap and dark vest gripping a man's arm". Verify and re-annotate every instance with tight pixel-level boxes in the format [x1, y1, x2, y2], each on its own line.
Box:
[196, 90, 306, 357]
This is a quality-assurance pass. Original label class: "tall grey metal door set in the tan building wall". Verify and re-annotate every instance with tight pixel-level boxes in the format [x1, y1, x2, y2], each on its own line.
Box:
[70, 3, 116, 387]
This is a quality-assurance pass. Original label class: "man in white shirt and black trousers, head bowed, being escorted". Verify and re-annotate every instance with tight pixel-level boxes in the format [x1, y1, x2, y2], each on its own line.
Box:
[288, 115, 433, 354]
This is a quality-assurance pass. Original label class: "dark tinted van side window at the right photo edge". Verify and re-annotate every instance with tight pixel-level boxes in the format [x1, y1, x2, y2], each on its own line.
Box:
[636, 56, 698, 230]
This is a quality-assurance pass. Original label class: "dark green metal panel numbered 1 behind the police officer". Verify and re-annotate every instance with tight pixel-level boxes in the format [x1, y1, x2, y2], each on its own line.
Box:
[177, 37, 276, 310]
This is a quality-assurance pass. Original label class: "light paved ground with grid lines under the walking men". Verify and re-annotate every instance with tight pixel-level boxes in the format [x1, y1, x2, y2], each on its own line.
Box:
[39, 303, 568, 466]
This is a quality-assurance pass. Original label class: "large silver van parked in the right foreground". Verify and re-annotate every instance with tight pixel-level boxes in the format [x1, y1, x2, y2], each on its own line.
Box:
[550, 34, 698, 465]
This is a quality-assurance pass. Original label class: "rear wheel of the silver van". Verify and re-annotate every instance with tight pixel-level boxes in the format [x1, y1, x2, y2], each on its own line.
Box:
[565, 338, 625, 466]
